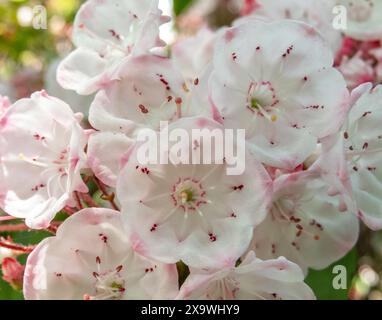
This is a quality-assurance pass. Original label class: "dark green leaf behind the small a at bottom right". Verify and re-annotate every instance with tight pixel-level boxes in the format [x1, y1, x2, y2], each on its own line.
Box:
[305, 249, 357, 300]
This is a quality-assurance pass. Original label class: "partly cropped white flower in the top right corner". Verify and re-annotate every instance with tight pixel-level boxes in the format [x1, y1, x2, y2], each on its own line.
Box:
[333, 0, 382, 41]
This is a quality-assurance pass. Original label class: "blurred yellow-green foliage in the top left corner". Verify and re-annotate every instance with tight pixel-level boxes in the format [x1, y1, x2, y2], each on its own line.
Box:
[0, 0, 81, 79]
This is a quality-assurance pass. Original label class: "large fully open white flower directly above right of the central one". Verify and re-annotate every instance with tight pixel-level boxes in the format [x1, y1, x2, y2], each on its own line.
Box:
[210, 20, 349, 170]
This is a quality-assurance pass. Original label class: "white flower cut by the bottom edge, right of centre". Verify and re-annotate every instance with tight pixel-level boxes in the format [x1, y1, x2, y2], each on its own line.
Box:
[177, 251, 315, 300]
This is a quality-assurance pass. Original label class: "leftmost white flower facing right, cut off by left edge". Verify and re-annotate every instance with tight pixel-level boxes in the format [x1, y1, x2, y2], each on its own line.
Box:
[0, 91, 87, 229]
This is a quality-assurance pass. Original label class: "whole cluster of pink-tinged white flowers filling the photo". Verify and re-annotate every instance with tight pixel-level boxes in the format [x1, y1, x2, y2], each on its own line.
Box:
[0, 0, 382, 300]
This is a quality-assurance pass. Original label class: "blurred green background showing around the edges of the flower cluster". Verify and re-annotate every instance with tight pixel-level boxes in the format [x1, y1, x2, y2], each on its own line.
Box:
[0, 0, 382, 300]
